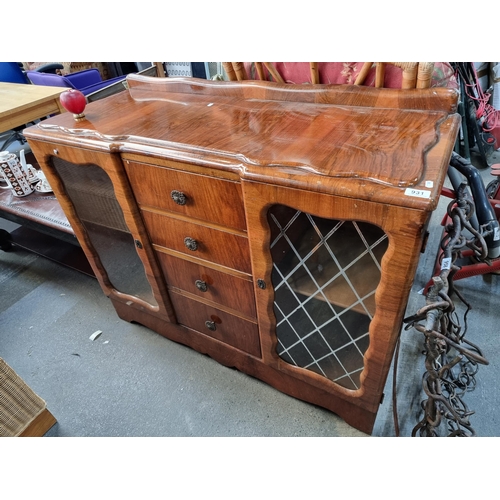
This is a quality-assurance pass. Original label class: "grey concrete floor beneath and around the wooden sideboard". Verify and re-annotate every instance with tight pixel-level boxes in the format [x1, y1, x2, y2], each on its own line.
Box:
[0, 153, 500, 437]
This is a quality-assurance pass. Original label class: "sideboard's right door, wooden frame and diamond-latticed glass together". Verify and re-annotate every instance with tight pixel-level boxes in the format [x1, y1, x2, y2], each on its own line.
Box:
[242, 181, 428, 418]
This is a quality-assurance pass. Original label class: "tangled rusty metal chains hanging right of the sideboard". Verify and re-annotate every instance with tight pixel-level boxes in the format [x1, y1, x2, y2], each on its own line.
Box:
[404, 182, 490, 437]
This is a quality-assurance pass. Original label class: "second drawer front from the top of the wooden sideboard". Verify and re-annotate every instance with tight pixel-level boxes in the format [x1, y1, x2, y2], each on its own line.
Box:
[142, 211, 251, 274]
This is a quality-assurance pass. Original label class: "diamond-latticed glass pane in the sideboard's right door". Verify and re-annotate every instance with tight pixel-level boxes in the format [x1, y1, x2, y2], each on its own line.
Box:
[267, 205, 388, 390]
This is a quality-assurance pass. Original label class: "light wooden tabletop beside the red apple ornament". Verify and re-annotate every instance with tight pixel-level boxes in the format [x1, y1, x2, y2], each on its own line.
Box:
[0, 82, 67, 133]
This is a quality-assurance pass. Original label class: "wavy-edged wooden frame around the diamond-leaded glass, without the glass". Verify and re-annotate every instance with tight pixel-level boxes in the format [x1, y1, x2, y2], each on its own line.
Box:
[242, 180, 429, 414]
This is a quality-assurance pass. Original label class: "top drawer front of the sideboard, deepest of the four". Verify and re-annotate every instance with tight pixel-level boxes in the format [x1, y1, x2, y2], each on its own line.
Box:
[125, 161, 246, 230]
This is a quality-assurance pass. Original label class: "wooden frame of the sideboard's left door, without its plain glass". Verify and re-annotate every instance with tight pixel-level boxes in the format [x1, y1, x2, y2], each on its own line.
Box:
[29, 139, 176, 323]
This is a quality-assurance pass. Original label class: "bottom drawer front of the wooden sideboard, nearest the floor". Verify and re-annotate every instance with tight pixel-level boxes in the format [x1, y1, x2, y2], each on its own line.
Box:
[170, 292, 261, 357]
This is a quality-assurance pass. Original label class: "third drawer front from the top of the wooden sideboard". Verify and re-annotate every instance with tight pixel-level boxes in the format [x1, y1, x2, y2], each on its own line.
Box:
[157, 252, 256, 318]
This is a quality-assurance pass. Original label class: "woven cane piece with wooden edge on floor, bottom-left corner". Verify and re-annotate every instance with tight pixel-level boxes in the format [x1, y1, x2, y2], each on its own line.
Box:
[0, 358, 56, 437]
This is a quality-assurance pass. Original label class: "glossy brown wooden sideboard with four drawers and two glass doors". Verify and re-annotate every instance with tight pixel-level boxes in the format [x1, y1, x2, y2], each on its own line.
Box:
[25, 75, 459, 433]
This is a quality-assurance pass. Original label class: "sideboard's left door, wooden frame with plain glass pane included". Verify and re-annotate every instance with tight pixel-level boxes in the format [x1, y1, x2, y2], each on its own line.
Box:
[28, 143, 176, 320]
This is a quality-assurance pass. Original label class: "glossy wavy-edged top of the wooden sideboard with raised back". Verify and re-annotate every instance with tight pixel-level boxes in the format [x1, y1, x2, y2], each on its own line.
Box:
[26, 77, 459, 209]
